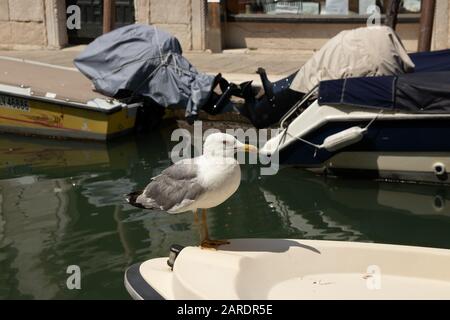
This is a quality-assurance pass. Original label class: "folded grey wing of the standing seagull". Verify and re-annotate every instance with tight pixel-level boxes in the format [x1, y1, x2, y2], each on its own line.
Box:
[136, 159, 205, 212]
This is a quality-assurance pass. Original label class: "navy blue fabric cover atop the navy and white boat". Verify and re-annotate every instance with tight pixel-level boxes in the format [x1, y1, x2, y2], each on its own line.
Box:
[318, 50, 450, 113]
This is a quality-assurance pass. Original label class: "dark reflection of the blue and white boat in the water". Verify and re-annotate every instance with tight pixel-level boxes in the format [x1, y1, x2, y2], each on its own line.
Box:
[260, 174, 450, 248]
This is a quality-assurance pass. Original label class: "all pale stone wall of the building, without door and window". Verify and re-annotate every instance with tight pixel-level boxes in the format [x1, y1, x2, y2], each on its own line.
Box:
[0, 0, 450, 51]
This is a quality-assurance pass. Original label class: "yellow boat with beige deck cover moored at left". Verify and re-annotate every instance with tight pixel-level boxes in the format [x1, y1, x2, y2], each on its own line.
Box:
[0, 57, 141, 141]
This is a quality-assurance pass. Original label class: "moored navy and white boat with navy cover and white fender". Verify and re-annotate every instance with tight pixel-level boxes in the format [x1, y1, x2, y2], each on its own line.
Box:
[262, 50, 450, 183]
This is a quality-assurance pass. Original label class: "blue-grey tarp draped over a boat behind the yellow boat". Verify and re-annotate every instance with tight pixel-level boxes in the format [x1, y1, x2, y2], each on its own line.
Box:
[74, 24, 215, 117]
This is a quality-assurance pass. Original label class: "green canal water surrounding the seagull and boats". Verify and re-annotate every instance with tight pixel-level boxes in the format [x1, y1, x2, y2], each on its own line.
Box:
[0, 131, 450, 299]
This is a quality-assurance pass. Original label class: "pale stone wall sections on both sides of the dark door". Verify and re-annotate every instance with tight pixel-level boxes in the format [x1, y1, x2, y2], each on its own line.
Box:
[0, 0, 201, 50]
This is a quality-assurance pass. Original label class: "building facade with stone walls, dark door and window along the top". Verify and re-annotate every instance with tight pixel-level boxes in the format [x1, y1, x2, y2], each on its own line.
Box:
[0, 0, 450, 52]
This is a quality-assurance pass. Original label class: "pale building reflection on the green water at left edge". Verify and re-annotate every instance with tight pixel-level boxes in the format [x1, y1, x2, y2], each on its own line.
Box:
[0, 176, 70, 299]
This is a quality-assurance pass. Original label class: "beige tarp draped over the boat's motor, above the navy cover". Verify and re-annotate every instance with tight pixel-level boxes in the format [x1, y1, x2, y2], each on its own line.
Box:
[290, 26, 414, 93]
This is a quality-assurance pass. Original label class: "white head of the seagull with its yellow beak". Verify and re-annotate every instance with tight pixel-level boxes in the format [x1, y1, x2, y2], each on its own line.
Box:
[203, 133, 258, 158]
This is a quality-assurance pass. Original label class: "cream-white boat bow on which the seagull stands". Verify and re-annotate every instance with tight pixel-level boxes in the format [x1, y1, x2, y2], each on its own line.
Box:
[125, 239, 450, 300]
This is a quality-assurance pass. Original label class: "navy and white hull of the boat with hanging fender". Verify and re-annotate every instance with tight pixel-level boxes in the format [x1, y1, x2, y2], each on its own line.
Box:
[260, 102, 450, 183]
